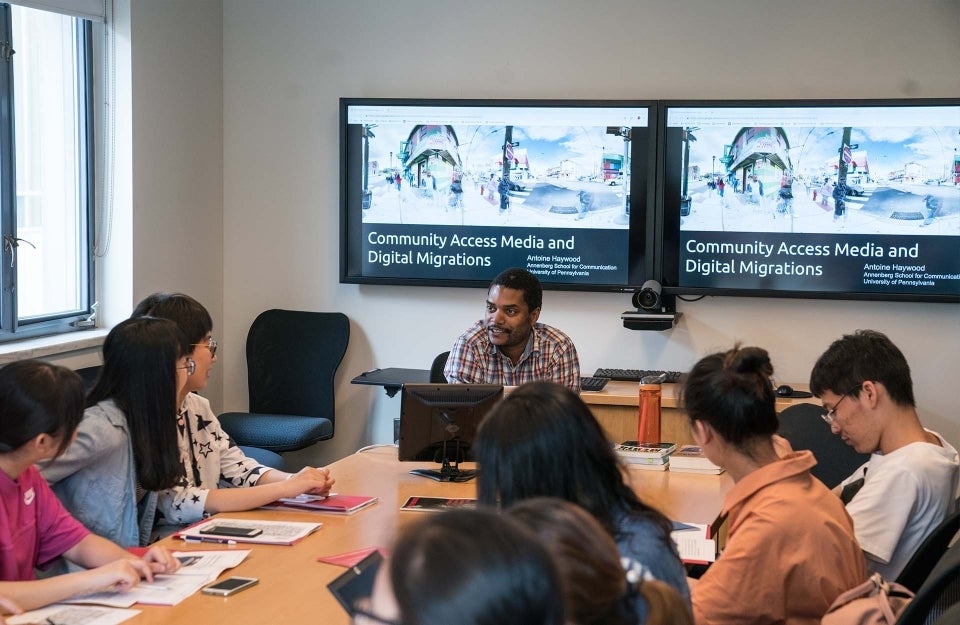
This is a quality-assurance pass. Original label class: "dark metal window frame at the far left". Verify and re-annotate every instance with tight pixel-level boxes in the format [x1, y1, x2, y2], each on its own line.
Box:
[0, 4, 96, 344]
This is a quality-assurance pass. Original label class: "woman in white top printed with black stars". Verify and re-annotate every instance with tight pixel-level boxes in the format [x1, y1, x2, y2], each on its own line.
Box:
[133, 293, 333, 524]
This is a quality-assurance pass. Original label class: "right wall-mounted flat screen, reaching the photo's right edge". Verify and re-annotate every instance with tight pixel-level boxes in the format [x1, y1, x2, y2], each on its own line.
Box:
[660, 100, 960, 302]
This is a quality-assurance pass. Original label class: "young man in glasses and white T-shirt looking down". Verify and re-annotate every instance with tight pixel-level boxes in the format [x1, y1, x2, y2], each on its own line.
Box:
[810, 330, 960, 580]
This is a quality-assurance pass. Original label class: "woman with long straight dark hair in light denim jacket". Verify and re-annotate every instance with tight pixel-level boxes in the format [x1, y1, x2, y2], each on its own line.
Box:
[41, 317, 196, 547]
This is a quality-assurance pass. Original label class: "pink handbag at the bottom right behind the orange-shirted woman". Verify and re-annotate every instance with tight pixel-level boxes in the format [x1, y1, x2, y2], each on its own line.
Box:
[820, 573, 913, 625]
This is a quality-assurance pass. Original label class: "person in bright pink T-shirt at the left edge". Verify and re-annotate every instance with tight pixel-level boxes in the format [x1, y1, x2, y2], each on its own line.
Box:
[0, 360, 179, 610]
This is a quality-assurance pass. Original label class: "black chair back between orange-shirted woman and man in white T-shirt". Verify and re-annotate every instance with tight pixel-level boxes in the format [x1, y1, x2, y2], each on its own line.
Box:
[777, 403, 870, 488]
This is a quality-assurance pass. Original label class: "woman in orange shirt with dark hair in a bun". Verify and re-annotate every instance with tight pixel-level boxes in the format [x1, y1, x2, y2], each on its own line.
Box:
[682, 347, 867, 625]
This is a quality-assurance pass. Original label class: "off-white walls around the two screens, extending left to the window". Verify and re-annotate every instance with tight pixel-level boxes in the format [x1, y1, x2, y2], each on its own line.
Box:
[139, 0, 960, 462]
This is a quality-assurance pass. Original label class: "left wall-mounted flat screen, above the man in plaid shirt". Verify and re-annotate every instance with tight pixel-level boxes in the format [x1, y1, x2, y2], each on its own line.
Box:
[340, 99, 656, 291]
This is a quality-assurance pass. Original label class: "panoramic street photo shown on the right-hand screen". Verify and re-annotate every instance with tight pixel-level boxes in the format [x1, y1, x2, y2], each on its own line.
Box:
[681, 122, 960, 236]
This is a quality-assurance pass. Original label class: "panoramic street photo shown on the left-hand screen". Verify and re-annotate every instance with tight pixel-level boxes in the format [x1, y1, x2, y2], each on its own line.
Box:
[363, 124, 629, 228]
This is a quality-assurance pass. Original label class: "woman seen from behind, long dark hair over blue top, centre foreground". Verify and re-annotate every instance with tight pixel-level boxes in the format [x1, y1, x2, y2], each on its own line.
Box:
[476, 382, 690, 621]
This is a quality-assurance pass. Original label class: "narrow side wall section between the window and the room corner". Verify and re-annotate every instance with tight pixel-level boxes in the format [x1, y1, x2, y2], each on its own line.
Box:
[124, 0, 224, 406]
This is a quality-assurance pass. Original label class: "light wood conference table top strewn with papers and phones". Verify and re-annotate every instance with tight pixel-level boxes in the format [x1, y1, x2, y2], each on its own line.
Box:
[126, 445, 733, 625]
